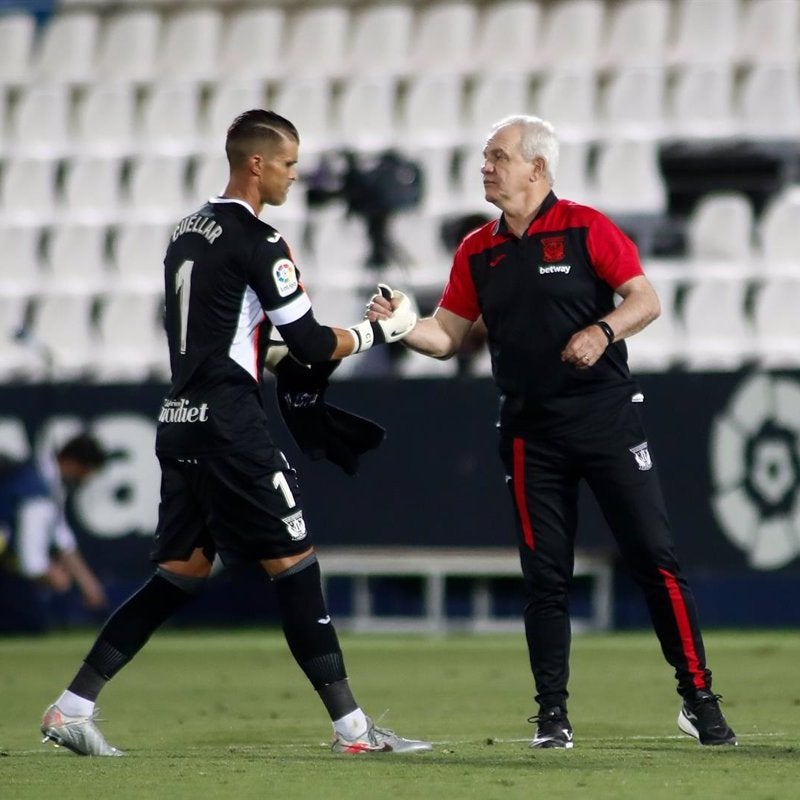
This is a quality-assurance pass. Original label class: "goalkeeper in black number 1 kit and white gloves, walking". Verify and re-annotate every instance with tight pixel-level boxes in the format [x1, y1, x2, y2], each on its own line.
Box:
[41, 110, 431, 756]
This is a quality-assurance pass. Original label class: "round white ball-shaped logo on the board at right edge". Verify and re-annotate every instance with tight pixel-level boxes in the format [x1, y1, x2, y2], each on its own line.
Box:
[710, 375, 800, 569]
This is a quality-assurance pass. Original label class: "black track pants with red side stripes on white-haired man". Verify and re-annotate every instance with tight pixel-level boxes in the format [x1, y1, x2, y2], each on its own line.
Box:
[500, 390, 711, 707]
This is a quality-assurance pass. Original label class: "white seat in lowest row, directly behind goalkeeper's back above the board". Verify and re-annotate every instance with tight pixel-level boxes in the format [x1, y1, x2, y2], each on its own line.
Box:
[92, 291, 169, 382]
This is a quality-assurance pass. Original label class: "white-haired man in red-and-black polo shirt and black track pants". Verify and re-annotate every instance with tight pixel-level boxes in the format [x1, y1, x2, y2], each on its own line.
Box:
[368, 116, 736, 748]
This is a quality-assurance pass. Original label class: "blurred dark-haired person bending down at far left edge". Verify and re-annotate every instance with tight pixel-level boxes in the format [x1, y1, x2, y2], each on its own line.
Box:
[0, 433, 107, 632]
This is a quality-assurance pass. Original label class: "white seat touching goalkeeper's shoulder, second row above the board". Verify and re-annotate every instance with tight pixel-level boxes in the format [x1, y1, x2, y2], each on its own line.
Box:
[111, 219, 171, 293]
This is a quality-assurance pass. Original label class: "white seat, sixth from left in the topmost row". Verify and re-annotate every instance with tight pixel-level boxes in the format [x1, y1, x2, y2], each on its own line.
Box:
[283, 4, 350, 79]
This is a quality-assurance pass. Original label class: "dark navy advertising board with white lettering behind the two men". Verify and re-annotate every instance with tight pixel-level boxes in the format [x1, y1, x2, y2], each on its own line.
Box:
[0, 372, 800, 624]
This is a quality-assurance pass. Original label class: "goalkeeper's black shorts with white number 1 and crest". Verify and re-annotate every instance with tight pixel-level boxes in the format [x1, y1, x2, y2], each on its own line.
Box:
[150, 449, 311, 564]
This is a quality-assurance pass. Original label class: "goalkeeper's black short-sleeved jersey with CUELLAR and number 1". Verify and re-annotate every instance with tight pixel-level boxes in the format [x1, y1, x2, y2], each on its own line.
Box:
[156, 198, 311, 456]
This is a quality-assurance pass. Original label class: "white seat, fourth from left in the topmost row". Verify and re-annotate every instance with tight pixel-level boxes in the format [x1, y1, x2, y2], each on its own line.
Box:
[155, 5, 223, 82]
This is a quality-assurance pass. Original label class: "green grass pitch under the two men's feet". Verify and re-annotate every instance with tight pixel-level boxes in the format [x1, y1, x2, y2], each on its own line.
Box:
[0, 630, 800, 800]
